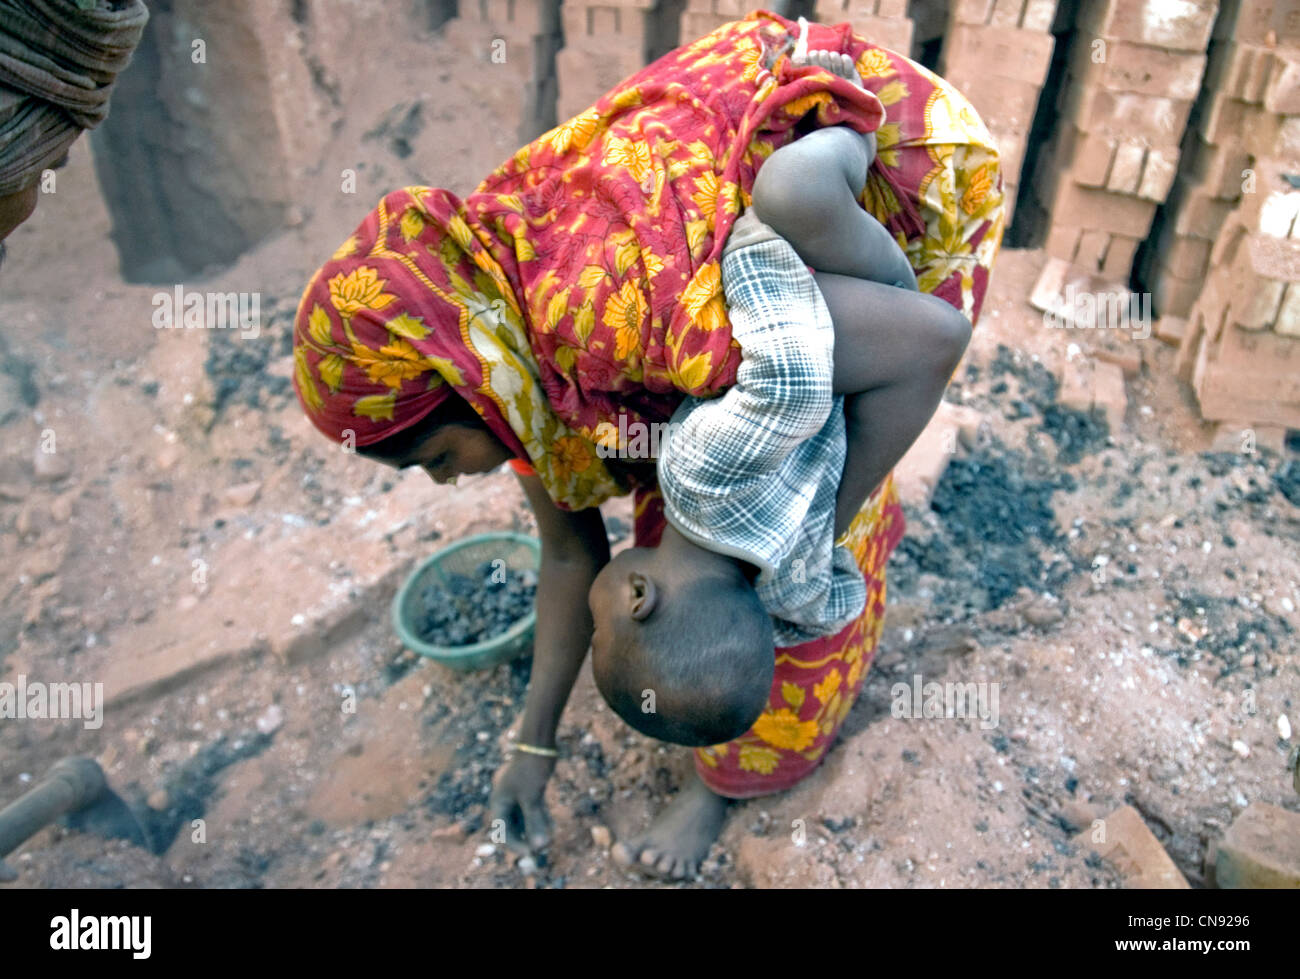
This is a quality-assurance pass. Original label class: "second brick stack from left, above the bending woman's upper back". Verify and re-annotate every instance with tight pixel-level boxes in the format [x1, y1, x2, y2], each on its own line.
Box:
[555, 0, 665, 121]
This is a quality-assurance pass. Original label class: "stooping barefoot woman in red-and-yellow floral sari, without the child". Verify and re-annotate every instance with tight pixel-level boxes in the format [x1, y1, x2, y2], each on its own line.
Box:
[295, 10, 1002, 876]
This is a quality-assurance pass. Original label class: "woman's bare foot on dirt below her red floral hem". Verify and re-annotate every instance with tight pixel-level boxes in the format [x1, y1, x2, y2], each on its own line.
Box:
[611, 775, 727, 880]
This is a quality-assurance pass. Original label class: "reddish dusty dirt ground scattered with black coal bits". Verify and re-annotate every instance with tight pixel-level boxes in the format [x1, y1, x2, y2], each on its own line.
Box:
[0, 26, 1300, 888]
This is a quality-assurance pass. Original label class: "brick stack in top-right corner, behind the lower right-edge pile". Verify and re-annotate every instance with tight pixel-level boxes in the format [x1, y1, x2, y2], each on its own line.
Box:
[1141, 0, 1300, 317]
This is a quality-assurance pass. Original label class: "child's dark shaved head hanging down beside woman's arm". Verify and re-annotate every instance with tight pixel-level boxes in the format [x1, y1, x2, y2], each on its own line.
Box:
[589, 547, 775, 746]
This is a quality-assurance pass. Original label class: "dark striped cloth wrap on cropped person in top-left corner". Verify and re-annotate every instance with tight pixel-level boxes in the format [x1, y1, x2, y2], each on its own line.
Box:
[0, 0, 150, 196]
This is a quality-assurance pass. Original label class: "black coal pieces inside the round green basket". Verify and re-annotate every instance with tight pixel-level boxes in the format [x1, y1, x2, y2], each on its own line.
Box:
[416, 562, 537, 646]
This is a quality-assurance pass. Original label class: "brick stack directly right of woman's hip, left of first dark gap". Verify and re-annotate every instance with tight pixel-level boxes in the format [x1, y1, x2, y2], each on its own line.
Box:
[943, 0, 1057, 220]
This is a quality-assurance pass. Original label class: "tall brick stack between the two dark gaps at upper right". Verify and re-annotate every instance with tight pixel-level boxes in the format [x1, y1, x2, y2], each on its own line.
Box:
[1034, 0, 1218, 283]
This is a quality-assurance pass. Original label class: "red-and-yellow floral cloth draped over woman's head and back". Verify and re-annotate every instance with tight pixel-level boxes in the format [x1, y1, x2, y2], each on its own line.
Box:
[294, 12, 884, 508]
